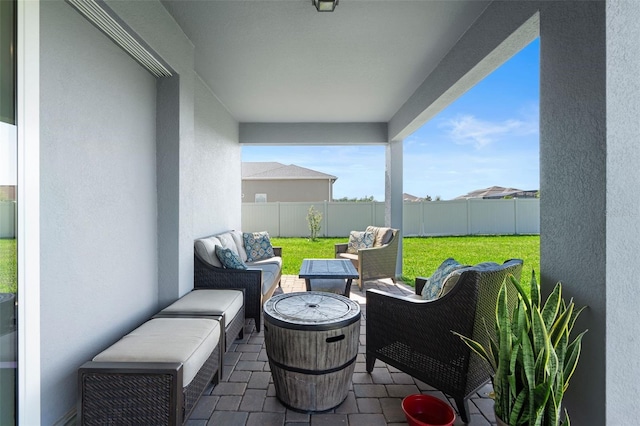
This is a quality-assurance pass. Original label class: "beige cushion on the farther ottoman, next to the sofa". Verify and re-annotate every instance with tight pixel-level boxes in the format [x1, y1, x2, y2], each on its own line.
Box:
[160, 289, 244, 325]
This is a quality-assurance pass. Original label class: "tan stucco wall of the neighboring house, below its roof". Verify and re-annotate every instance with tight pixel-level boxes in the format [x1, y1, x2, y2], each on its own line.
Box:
[242, 179, 332, 203]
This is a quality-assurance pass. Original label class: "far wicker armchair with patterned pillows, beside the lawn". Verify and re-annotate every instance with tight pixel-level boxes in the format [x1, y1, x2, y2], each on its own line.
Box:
[335, 226, 400, 290]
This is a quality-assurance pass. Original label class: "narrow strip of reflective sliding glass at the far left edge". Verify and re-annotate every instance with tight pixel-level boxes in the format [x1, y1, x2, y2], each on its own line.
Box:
[0, 0, 18, 426]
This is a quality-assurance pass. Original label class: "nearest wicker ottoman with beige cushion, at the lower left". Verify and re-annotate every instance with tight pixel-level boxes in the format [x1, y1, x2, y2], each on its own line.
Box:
[78, 318, 222, 425]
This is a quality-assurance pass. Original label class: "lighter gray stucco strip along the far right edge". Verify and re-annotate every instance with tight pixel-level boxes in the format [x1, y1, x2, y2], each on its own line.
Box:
[604, 0, 640, 425]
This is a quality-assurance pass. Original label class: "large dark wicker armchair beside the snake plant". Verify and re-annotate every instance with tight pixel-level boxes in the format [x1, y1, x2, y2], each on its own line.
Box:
[366, 259, 522, 423]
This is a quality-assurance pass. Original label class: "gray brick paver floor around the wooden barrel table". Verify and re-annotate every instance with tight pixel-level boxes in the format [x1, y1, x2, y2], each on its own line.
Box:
[186, 275, 495, 426]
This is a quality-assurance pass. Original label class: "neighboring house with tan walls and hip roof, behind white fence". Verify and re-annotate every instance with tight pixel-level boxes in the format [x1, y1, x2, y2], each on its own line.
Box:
[242, 162, 338, 203]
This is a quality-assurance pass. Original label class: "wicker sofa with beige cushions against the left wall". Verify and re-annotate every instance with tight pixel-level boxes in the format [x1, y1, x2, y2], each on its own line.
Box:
[193, 231, 282, 331]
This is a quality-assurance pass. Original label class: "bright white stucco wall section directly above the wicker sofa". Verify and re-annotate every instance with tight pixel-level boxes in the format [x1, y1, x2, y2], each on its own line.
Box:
[191, 78, 242, 238]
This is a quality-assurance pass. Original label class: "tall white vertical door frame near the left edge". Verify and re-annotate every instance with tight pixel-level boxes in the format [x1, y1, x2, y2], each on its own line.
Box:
[16, 0, 41, 425]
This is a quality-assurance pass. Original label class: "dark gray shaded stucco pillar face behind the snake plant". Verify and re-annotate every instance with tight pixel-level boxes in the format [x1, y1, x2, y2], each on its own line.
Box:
[540, 2, 604, 425]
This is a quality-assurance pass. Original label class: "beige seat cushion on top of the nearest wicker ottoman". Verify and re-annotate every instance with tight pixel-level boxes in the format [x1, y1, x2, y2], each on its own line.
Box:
[93, 318, 221, 388]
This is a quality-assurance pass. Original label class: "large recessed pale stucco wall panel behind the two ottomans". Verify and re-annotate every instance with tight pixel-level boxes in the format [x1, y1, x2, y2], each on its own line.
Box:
[40, 1, 158, 425]
